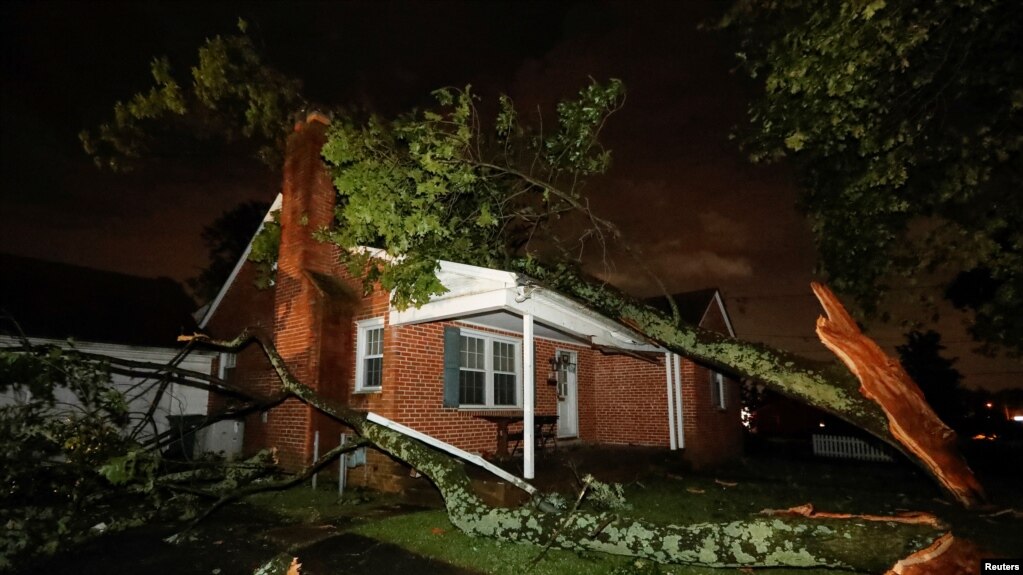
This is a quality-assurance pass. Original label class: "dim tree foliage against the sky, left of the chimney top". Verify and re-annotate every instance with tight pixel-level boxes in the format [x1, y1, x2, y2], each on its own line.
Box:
[79, 19, 305, 171]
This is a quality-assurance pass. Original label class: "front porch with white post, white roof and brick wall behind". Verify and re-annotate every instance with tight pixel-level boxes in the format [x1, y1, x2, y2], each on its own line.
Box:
[387, 257, 684, 481]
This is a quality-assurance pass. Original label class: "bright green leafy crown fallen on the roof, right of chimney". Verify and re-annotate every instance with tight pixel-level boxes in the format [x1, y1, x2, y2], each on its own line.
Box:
[323, 80, 624, 307]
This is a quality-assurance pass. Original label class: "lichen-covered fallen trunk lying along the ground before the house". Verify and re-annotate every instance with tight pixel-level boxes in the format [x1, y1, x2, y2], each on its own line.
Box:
[193, 335, 945, 572]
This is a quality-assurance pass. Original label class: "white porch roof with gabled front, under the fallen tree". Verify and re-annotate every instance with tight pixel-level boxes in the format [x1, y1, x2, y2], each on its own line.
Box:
[389, 261, 664, 352]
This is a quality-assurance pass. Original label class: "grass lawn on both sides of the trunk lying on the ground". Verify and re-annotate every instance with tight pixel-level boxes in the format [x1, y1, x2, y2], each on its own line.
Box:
[26, 453, 1023, 575]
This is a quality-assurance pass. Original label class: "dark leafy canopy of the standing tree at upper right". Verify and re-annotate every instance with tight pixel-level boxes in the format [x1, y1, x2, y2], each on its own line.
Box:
[721, 0, 1023, 354]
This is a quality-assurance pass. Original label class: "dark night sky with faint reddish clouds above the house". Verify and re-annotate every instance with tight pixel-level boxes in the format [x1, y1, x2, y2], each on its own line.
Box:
[0, 0, 1021, 388]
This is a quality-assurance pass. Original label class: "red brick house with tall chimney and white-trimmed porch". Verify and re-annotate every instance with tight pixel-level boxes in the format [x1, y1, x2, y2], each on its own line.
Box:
[199, 117, 742, 490]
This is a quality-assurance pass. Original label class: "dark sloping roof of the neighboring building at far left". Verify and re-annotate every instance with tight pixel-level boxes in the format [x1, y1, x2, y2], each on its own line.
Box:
[0, 254, 196, 347]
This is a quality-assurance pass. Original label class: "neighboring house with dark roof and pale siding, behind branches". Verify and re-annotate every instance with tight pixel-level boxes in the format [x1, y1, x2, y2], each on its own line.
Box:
[0, 254, 219, 447]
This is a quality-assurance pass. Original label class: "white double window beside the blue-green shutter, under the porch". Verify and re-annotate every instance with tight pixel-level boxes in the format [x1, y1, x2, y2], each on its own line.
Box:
[458, 333, 520, 407]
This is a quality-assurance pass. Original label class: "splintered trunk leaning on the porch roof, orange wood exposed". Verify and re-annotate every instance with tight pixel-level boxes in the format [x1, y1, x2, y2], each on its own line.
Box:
[521, 262, 984, 507]
